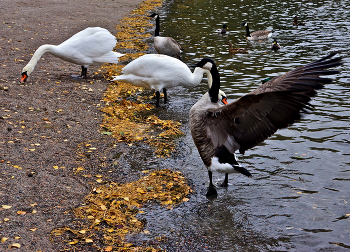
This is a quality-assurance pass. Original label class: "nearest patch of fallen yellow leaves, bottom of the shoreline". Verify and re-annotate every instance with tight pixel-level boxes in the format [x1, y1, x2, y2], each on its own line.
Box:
[52, 169, 191, 251]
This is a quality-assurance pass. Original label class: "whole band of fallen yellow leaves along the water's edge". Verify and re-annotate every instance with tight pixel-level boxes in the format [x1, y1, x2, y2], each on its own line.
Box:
[51, 0, 192, 251]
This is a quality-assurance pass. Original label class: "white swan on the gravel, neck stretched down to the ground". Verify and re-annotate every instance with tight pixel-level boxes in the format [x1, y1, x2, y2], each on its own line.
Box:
[21, 27, 124, 82]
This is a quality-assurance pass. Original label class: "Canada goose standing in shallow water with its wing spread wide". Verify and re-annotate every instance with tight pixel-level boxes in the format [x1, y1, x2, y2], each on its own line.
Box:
[190, 53, 342, 196]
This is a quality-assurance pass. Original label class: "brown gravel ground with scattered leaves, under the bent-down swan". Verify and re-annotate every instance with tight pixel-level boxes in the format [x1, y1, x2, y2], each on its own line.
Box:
[0, 0, 146, 251]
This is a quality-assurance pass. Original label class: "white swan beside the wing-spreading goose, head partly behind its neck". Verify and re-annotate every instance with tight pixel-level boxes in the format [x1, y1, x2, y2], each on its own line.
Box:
[113, 54, 210, 107]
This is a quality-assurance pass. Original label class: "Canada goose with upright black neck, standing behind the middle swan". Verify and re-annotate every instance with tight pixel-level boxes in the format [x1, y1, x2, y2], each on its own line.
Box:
[149, 13, 184, 59]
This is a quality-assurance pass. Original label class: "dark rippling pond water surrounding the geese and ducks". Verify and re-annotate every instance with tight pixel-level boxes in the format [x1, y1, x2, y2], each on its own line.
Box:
[133, 0, 350, 251]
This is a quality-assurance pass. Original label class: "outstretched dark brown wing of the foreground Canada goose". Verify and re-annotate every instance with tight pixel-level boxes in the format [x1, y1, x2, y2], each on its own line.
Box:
[206, 53, 342, 154]
